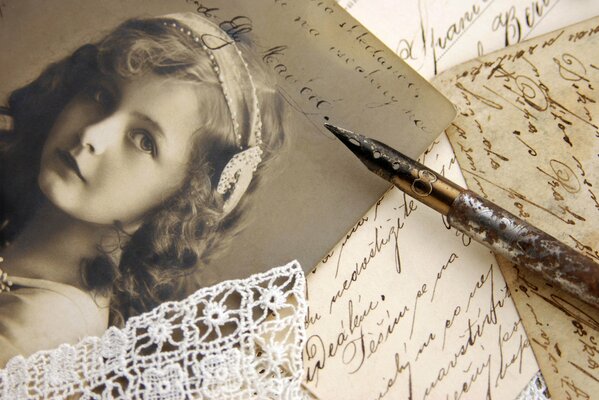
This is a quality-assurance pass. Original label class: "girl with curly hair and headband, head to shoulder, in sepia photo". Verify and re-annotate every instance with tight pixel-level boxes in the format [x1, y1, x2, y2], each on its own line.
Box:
[0, 13, 284, 365]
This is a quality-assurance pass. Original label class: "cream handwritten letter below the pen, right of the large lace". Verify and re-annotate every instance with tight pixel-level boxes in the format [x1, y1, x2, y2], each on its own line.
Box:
[304, 136, 538, 399]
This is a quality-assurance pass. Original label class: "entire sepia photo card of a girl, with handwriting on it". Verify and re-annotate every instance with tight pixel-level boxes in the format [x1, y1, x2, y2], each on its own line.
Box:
[0, 0, 454, 368]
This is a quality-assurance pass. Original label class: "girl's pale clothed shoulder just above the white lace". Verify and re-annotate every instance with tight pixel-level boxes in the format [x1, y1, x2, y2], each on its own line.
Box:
[0, 277, 108, 365]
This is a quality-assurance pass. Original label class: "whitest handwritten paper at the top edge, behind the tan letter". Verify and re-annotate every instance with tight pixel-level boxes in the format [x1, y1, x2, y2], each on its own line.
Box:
[339, 0, 599, 76]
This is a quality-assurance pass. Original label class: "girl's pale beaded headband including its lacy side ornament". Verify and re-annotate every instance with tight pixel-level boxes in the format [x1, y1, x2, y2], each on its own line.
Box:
[161, 13, 262, 213]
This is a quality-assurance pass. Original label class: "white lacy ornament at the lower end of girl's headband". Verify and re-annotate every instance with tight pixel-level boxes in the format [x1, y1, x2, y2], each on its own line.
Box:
[216, 146, 262, 215]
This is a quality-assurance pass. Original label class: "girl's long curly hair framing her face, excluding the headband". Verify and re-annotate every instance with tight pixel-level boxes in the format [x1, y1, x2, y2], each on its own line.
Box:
[0, 19, 285, 325]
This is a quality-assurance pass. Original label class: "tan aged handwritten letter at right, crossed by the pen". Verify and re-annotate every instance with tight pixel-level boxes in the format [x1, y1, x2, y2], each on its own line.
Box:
[435, 19, 599, 399]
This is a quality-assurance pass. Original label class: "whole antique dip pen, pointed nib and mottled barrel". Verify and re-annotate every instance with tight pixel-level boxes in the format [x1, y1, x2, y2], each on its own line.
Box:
[325, 124, 599, 307]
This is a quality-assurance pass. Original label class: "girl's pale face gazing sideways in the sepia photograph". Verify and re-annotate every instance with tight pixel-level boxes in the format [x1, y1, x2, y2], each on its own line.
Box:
[38, 74, 201, 225]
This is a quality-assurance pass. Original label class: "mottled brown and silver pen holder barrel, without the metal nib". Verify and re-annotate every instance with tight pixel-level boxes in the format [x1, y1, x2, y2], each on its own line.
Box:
[447, 190, 599, 307]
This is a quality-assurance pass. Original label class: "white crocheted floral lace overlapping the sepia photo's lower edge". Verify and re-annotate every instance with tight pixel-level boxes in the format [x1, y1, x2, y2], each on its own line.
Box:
[0, 261, 306, 400]
